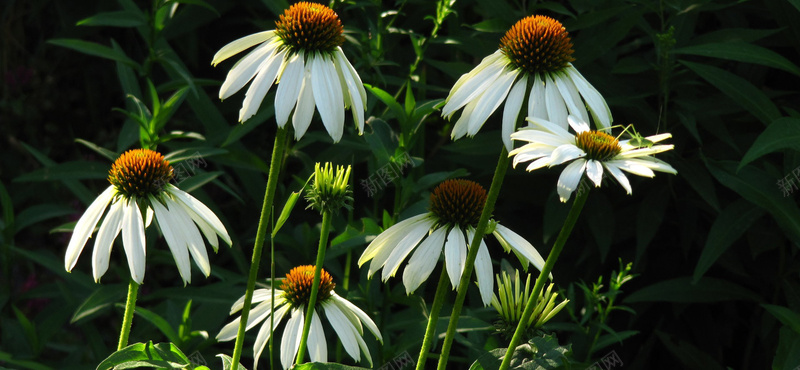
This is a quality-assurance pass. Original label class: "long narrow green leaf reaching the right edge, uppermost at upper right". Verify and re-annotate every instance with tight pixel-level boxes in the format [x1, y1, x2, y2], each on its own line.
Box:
[673, 42, 800, 76]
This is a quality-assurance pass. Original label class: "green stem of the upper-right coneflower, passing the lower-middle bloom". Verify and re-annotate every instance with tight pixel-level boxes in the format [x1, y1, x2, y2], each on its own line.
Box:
[438, 145, 509, 370]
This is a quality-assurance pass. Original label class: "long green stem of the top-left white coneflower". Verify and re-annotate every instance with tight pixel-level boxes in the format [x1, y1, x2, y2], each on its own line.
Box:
[231, 127, 289, 367]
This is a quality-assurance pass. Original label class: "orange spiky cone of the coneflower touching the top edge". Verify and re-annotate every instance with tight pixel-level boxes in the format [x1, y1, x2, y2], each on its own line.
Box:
[275, 1, 344, 52]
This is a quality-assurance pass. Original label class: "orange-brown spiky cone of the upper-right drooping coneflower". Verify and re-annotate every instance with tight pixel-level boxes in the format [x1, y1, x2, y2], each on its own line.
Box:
[500, 15, 575, 74]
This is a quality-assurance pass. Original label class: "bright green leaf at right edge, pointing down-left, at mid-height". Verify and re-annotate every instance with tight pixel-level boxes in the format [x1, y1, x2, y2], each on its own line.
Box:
[738, 117, 800, 170]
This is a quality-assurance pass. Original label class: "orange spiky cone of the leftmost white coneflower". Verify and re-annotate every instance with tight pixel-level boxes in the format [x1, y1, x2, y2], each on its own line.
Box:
[108, 149, 173, 198]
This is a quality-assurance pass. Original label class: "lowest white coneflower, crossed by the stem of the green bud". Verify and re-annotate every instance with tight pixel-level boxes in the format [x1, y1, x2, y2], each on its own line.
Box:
[217, 265, 383, 369]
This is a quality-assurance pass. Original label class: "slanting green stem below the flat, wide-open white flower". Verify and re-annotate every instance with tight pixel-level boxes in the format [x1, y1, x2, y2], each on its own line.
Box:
[500, 184, 589, 370]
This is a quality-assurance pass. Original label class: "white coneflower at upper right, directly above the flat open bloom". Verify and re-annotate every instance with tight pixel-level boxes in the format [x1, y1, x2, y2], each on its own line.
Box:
[442, 15, 611, 151]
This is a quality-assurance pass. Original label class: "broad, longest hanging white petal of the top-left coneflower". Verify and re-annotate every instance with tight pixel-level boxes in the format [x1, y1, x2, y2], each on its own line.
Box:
[310, 54, 344, 143]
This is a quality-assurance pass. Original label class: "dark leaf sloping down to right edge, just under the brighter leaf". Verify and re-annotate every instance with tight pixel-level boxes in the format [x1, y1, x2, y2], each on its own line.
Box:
[706, 160, 800, 242]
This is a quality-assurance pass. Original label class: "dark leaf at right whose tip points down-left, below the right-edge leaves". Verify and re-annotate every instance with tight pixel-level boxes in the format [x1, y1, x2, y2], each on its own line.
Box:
[692, 199, 764, 283]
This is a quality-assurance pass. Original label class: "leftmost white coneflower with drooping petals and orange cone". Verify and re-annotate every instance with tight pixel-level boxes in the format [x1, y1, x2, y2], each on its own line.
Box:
[64, 149, 231, 284]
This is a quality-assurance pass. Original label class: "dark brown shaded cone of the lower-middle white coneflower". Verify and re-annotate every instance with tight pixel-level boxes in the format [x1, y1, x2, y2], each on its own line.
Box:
[430, 179, 486, 227]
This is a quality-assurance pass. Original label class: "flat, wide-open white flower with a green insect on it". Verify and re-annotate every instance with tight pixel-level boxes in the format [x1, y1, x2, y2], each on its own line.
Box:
[509, 116, 677, 202]
